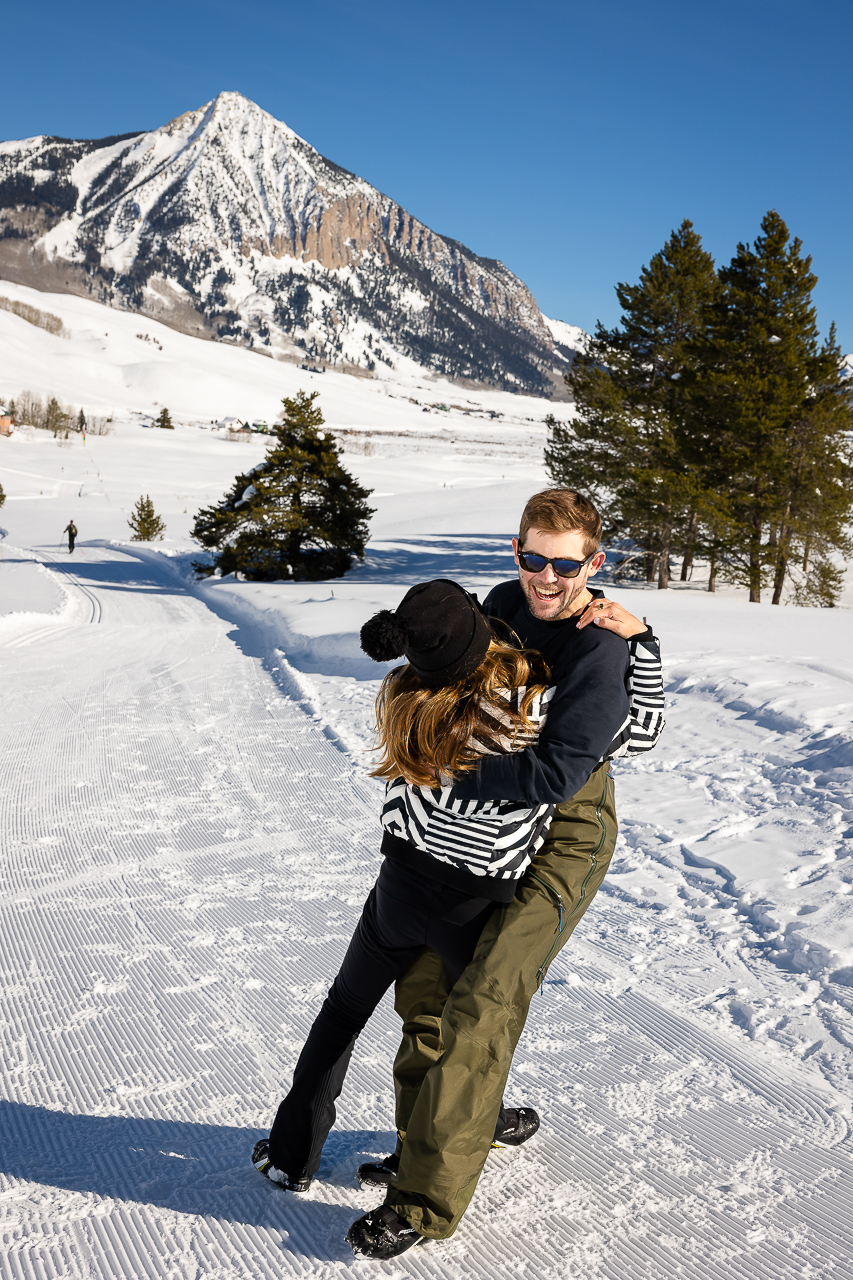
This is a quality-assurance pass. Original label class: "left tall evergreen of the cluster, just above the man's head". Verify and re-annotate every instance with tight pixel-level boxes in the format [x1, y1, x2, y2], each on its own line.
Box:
[546, 220, 719, 588]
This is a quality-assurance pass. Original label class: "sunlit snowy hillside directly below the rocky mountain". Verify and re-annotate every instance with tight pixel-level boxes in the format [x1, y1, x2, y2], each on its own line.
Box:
[0, 279, 553, 430]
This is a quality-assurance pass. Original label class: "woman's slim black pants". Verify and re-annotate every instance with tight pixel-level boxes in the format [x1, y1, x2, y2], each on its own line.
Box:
[269, 859, 494, 1178]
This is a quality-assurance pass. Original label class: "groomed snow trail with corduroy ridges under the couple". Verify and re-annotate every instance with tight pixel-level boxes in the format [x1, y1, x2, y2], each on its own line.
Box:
[0, 545, 853, 1280]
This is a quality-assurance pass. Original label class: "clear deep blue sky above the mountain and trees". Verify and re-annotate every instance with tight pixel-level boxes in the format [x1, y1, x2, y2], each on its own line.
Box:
[0, 0, 853, 351]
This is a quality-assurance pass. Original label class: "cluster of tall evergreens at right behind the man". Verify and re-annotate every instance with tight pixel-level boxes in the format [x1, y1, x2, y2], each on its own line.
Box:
[546, 211, 853, 605]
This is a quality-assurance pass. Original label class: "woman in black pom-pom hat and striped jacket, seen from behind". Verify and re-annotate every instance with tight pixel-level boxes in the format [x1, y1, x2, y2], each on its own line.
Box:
[252, 579, 553, 1192]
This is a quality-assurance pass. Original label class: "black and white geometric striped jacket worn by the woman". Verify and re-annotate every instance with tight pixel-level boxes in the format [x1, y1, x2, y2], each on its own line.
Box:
[382, 632, 663, 881]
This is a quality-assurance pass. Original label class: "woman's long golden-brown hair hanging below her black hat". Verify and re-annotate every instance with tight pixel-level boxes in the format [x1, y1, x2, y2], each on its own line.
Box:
[370, 637, 549, 787]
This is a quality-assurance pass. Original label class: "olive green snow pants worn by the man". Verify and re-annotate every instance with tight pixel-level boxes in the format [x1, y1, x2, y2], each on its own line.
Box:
[386, 764, 616, 1239]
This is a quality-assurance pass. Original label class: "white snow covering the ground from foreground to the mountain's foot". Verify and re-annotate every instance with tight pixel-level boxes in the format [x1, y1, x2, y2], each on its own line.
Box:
[0, 282, 853, 1280]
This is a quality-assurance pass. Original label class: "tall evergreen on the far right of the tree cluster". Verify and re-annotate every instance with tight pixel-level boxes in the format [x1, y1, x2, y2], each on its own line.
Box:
[685, 210, 850, 604]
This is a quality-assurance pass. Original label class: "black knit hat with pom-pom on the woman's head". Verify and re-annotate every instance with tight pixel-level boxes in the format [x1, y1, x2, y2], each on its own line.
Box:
[361, 577, 492, 689]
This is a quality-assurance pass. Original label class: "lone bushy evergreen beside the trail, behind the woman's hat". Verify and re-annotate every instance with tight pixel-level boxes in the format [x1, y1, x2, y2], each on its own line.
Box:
[193, 392, 373, 581]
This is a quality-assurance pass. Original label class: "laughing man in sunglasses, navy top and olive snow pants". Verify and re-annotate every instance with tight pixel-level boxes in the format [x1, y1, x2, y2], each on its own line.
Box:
[347, 489, 662, 1258]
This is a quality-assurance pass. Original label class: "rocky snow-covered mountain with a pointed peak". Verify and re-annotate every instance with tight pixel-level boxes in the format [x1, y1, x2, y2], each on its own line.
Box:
[0, 93, 571, 394]
